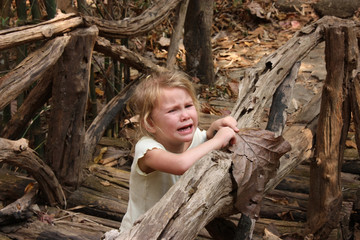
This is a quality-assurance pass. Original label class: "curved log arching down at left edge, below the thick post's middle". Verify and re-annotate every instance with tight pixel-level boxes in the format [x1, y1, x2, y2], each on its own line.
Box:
[0, 138, 66, 206]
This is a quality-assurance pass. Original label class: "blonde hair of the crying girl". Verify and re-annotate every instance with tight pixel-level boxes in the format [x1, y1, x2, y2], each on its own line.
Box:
[131, 72, 199, 136]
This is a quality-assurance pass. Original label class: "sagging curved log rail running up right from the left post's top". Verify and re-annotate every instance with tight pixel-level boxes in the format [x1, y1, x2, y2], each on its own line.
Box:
[83, 0, 181, 38]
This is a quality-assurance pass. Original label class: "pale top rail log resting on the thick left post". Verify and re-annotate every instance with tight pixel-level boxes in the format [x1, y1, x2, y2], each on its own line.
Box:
[0, 12, 83, 51]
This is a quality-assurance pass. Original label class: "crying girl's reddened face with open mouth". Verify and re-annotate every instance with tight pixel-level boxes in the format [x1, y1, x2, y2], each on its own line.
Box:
[148, 88, 198, 153]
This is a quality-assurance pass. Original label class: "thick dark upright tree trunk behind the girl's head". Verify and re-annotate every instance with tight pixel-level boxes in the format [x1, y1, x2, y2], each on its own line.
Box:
[184, 0, 215, 85]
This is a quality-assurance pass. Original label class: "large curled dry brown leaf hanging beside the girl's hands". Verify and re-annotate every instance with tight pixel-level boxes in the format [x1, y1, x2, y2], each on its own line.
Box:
[229, 129, 291, 218]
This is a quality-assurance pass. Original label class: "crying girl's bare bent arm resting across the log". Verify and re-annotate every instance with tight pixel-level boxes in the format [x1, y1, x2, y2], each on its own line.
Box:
[138, 127, 235, 175]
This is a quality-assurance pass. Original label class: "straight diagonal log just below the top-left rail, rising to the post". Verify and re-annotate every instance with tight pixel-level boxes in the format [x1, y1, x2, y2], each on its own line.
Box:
[0, 36, 70, 109]
